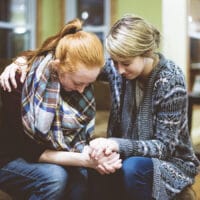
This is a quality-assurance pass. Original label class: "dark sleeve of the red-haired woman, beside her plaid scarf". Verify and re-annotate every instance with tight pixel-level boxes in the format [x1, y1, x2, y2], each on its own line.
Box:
[0, 76, 45, 167]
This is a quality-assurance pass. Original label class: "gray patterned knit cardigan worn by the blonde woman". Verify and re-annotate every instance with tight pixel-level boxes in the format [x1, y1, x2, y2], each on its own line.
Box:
[100, 54, 199, 200]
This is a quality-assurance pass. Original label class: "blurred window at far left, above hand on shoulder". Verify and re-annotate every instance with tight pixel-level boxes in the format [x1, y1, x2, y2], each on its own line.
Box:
[0, 0, 36, 63]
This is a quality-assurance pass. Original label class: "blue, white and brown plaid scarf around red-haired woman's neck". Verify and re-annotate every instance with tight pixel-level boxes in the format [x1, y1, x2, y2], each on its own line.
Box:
[22, 53, 95, 152]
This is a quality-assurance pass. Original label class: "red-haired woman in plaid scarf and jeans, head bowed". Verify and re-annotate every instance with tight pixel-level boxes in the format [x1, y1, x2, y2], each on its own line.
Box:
[0, 19, 121, 200]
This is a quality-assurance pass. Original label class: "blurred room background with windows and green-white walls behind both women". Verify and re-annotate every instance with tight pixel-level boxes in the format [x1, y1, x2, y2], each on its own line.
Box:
[0, 0, 200, 150]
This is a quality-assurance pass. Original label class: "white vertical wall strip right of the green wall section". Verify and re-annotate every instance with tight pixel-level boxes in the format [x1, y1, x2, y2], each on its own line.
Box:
[162, 0, 189, 79]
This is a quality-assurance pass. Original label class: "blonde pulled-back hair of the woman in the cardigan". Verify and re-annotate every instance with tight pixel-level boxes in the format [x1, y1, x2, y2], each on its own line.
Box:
[106, 14, 160, 60]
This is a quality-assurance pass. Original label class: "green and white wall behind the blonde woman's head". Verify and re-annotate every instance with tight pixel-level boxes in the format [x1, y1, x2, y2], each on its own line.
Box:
[116, 0, 188, 78]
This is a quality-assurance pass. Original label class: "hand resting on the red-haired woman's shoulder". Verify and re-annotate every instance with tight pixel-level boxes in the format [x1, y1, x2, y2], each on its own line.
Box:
[0, 57, 28, 92]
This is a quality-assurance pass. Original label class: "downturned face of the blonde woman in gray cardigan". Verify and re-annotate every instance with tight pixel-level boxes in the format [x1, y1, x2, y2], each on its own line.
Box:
[113, 56, 153, 80]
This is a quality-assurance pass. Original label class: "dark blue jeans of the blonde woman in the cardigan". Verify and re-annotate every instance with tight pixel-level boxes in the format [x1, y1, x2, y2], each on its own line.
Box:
[89, 157, 153, 200]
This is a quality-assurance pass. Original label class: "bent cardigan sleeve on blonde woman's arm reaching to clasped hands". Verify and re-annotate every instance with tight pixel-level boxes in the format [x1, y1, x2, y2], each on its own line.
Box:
[113, 67, 197, 160]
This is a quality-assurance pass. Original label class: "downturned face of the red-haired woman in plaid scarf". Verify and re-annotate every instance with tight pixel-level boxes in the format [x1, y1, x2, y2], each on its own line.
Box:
[58, 63, 100, 93]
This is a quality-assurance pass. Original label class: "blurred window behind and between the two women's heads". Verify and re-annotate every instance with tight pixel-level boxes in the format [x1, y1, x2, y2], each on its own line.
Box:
[66, 0, 110, 42]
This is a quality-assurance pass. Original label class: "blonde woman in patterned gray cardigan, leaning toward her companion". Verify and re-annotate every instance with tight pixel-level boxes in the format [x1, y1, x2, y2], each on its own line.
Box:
[90, 15, 199, 200]
